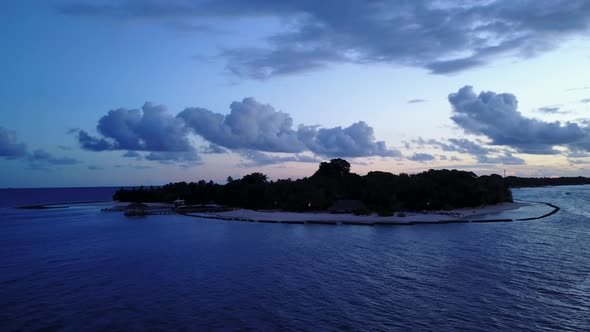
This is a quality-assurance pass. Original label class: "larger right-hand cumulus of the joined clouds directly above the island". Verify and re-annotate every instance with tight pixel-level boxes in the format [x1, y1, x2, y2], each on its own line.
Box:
[178, 98, 401, 157]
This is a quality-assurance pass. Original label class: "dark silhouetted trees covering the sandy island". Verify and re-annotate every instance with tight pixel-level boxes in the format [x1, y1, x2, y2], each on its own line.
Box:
[113, 159, 512, 215]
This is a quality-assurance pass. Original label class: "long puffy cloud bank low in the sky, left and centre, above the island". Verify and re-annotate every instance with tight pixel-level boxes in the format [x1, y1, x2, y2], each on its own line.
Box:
[78, 98, 401, 164]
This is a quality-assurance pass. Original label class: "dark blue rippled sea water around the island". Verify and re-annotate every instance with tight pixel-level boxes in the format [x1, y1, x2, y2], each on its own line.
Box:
[0, 186, 590, 331]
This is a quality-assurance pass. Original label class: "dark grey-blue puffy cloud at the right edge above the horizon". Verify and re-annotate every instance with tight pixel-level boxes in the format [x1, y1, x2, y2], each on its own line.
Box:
[449, 86, 588, 154]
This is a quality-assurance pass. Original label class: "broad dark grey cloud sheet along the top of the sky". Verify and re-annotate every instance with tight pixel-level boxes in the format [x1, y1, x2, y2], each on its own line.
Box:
[58, 0, 590, 79]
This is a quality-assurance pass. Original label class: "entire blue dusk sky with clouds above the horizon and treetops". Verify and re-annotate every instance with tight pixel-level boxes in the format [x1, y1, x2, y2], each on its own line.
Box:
[0, 0, 590, 188]
